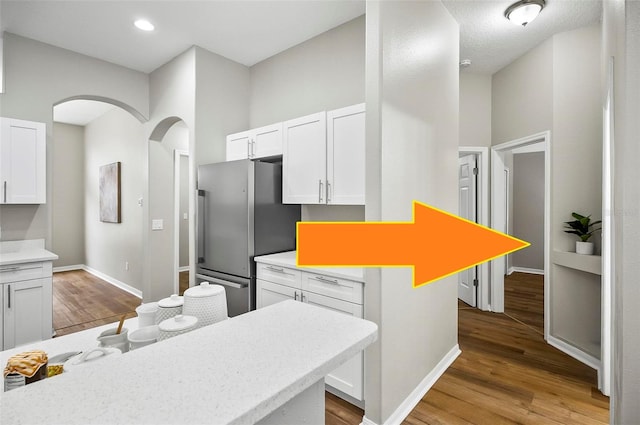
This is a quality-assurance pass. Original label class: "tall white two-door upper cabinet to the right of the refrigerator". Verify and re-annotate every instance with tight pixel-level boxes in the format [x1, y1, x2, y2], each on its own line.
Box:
[282, 104, 365, 205]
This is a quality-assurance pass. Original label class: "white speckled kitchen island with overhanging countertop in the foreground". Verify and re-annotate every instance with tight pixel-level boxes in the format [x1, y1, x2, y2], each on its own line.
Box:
[0, 301, 377, 424]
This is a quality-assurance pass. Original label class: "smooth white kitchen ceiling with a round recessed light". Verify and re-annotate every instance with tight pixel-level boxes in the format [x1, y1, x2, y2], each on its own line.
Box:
[0, 0, 365, 72]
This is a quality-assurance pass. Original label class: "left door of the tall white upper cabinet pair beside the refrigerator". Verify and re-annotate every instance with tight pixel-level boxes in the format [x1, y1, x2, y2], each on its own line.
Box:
[282, 112, 327, 204]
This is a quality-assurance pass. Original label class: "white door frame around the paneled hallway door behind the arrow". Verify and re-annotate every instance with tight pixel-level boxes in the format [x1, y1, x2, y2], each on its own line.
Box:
[458, 146, 491, 311]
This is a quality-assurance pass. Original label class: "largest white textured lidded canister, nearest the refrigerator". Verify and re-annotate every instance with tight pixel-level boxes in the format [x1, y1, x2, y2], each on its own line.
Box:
[182, 282, 228, 328]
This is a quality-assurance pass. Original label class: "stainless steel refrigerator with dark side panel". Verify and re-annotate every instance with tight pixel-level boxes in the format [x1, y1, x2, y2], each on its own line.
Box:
[196, 160, 300, 317]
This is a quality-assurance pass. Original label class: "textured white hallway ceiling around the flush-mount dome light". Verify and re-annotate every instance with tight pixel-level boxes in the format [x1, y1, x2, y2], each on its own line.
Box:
[442, 0, 602, 74]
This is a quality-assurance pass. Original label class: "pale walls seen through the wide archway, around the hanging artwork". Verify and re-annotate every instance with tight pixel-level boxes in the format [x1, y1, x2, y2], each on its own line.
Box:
[51, 96, 146, 298]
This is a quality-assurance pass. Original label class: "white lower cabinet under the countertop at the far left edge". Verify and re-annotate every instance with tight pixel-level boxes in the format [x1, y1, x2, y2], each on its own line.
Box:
[0, 262, 53, 350]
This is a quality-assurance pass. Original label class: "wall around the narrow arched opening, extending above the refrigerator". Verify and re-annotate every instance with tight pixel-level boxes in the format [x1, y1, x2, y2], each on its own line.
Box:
[144, 47, 249, 301]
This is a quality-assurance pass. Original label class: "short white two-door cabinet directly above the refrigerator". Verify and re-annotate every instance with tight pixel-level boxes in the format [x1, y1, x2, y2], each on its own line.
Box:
[227, 123, 282, 161]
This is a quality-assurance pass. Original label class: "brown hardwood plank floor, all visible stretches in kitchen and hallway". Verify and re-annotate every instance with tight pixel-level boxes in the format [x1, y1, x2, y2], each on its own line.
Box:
[53, 271, 609, 425]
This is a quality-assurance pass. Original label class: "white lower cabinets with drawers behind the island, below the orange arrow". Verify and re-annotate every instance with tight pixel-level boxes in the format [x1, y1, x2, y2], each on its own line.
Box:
[256, 263, 364, 401]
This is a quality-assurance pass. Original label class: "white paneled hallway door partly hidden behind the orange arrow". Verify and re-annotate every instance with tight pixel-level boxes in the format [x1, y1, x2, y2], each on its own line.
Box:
[458, 155, 477, 307]
